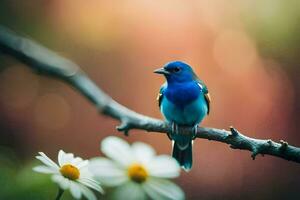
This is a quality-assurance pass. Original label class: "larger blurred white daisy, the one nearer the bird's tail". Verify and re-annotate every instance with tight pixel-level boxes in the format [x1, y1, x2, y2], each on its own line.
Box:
[89, 136, 184, 200]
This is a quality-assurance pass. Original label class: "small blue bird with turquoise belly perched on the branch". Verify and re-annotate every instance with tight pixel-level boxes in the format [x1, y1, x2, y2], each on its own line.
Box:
[154, 61, 210, 171]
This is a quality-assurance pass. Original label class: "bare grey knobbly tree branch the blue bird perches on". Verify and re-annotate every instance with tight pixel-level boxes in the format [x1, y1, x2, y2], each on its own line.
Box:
[0, 27, 300, 163]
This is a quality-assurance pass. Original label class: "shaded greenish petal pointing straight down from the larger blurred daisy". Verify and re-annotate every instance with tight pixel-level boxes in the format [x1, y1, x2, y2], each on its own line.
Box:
[113, 181, 146, 200]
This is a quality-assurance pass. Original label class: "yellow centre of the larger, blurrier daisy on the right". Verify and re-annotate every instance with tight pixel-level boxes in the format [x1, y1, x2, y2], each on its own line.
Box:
[127, 164, 148, 183]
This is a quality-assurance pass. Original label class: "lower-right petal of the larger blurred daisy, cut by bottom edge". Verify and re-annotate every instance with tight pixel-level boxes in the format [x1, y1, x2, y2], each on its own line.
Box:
[143, 178, 185, 200]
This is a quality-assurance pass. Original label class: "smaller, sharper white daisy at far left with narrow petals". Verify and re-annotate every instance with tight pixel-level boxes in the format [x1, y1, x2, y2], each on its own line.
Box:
[33, 150, 103, 200]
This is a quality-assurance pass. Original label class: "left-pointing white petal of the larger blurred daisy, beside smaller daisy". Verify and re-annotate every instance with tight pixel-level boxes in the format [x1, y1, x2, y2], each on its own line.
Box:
[89, 158, 128, 186]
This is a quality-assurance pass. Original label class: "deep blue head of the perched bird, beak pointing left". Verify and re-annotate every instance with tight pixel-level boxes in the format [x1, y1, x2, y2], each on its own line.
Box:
[154, 61, 196, 83]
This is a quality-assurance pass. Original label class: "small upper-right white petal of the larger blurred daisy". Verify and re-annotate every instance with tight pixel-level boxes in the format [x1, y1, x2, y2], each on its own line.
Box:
[131, 142, 155, 164]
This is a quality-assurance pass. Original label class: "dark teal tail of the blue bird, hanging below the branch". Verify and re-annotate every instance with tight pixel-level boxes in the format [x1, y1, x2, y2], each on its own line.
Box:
[172, 141, 193, 171]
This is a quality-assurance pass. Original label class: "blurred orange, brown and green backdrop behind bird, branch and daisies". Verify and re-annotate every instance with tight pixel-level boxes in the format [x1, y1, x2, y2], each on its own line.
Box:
[0, 0, 300, 200]
